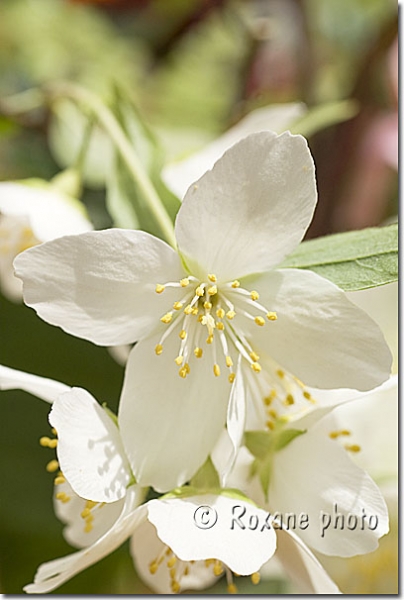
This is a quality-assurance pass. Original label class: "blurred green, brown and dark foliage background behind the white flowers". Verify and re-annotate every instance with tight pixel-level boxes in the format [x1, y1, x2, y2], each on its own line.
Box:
[0, 0, 398, 594]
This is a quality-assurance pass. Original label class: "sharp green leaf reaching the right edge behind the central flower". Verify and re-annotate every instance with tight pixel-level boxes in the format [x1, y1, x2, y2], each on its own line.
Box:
[279, 224, 398, 292]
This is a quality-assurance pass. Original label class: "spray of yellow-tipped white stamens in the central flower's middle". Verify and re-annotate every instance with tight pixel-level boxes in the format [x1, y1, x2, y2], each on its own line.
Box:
[155, 273, 277, 383]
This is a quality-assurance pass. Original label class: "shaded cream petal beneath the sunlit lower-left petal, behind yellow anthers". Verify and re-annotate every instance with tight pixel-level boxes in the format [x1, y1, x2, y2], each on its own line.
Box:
[53, 481, 124, 548]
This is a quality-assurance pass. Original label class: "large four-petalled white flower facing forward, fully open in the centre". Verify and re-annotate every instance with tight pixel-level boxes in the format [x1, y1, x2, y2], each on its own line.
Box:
[15, 132, 390, 492]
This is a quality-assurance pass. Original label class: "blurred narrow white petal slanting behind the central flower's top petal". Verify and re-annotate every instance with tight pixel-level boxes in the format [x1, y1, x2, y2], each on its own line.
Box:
[162, 103, 305, 198]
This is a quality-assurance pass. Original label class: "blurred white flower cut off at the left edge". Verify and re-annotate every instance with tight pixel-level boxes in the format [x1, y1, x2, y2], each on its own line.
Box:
[0, 180, 92, 301]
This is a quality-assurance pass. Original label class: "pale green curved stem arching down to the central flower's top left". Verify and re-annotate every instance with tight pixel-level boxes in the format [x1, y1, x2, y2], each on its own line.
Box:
[47, 82, 176, 248]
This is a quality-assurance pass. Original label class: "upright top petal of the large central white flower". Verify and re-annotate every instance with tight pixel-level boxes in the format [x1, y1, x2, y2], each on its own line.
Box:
[175, 132, 316, 280]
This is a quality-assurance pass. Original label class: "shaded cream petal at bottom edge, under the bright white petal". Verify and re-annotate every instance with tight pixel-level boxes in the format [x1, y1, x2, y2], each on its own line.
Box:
[130, 521, 217, 594]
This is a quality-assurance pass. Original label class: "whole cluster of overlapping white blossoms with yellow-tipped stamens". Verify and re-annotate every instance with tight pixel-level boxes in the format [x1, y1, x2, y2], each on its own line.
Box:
[0, 119, 395, 594]
